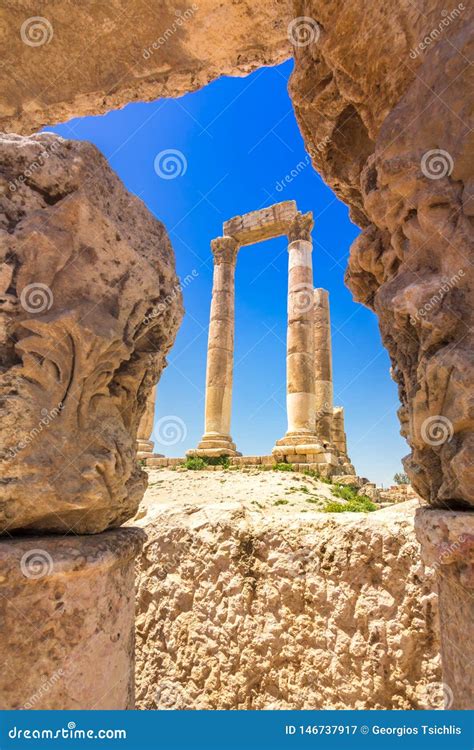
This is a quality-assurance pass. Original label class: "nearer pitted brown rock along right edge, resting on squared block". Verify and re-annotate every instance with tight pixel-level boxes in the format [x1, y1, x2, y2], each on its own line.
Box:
[347, 27, 474, 508]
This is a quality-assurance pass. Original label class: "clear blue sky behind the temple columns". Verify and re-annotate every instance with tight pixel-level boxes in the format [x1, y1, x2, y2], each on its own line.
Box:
[46, 57, 408, 484]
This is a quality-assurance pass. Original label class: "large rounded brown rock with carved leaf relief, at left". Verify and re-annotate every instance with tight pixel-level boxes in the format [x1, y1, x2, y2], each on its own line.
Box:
[0, 134, 182, 533]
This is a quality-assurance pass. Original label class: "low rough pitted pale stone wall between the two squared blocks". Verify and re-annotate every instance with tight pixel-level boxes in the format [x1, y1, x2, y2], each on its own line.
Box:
[134, 482, 442, 709]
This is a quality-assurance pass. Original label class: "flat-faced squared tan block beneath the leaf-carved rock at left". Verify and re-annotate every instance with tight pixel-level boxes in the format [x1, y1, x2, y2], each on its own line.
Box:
[0, 528, 144, 710]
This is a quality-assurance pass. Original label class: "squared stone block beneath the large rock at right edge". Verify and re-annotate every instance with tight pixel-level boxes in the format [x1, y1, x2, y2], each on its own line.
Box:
[415, 507, 474, 711]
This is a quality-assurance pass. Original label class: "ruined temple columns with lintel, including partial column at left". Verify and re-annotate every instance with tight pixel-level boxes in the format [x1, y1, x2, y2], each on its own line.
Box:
[138, 201, 355, 476]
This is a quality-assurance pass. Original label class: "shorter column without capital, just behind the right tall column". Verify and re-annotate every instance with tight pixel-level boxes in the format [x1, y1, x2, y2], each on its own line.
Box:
[313, 289, 334, 444]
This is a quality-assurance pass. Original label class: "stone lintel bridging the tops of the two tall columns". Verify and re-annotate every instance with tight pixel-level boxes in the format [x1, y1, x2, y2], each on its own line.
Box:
[222, 201, 298, 245]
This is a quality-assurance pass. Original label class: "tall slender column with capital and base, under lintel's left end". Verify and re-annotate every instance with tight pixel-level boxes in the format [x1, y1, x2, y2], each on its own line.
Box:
[188, 237, 240, 456]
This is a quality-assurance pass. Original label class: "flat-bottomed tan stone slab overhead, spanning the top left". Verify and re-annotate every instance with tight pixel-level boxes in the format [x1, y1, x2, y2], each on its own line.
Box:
[0, 0, 292, 133]
